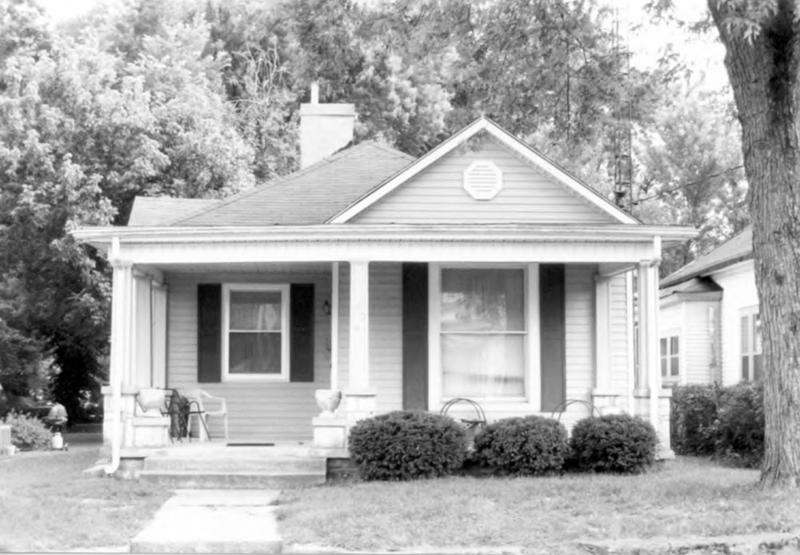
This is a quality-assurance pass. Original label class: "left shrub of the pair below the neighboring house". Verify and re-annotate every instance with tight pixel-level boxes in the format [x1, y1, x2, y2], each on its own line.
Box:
[670, 384, 720, 456]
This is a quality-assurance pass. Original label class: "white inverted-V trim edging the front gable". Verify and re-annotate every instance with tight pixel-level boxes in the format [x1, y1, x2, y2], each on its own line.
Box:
[330, 117, 640, 224]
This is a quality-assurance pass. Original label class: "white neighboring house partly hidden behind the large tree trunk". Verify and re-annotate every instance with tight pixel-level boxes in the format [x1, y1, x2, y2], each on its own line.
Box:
[659, 227, 762, 385]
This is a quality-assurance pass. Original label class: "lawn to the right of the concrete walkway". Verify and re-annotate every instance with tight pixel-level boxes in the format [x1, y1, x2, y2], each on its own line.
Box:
[279, 458, 800, 553]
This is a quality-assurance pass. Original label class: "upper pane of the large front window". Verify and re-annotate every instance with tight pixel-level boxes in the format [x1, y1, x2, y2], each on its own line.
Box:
[441, 269, 525, 331]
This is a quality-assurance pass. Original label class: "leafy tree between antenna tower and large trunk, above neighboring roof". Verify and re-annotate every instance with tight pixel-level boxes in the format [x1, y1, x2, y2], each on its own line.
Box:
[634, 82, 749, 275]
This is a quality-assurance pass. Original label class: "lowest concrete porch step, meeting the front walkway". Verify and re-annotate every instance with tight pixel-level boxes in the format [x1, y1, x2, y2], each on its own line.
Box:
[139, 468, 325, 489]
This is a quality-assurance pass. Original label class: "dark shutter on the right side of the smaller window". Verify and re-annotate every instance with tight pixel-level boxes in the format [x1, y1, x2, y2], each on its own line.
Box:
[289, 283, 314, 382]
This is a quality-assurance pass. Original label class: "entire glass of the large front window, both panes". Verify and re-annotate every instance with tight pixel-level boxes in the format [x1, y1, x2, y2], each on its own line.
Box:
[440, 268, 526, 399]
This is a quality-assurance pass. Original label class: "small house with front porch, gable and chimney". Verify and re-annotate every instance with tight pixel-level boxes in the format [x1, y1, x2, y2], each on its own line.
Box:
[74, 92, 694, 464]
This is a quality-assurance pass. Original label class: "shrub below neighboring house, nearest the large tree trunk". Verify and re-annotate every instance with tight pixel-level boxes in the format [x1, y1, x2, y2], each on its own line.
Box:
[715, 383, 764, 467]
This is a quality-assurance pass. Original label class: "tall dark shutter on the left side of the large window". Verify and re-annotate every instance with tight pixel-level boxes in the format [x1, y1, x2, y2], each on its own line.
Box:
[403, 263, 428, 410]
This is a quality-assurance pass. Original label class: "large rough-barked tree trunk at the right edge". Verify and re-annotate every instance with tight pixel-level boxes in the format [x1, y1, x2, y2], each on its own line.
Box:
[708, 0, 800, 486]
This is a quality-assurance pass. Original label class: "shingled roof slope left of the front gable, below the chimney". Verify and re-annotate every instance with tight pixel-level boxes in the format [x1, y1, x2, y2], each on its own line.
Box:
[128, 141, 414, 227]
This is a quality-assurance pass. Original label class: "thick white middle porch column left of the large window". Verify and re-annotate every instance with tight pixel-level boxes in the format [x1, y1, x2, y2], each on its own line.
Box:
[344, 260, 375, 420]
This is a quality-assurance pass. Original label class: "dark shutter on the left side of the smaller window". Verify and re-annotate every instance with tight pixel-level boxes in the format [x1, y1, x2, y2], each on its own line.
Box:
[197, 283, 222, 383]
